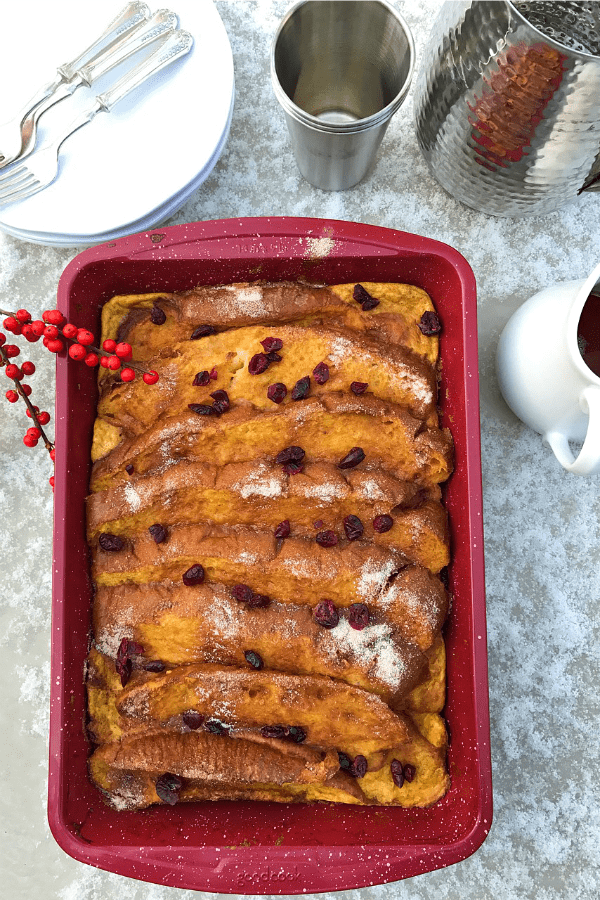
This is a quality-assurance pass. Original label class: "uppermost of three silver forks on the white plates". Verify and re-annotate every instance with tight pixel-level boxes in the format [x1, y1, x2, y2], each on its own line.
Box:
[0, 0, 150, 169]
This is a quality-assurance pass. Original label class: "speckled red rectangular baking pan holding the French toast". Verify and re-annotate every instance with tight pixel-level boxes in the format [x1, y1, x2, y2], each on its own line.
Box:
[48, 218, 492, 894]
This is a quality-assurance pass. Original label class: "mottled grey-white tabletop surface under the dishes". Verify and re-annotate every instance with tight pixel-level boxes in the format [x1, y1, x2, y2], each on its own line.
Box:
[0, 0, 600, 900]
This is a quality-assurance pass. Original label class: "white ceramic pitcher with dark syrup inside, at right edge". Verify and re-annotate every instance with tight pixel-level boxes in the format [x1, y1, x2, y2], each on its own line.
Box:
[496, 265, 600, 475]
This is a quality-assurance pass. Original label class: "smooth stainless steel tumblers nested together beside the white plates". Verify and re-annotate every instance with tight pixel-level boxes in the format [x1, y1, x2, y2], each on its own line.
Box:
[271, 0, 415, 191]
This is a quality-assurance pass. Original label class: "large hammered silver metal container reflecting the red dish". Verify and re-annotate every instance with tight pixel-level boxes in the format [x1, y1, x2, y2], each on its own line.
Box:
[415, 0, 600, 216]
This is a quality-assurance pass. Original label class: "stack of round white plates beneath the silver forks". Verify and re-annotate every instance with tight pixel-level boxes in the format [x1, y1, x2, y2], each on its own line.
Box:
[0, 0, 234, 247]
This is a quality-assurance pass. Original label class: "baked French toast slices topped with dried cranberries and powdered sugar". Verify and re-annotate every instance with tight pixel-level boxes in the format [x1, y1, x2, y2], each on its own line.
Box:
[86, 282, 453, 810]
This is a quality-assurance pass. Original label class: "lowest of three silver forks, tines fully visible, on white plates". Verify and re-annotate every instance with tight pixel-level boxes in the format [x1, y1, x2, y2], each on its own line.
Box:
[0, 31, 194, 207]
